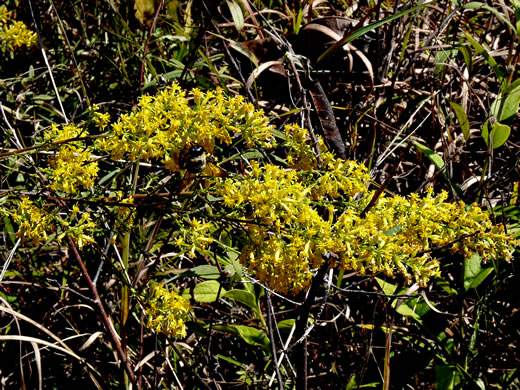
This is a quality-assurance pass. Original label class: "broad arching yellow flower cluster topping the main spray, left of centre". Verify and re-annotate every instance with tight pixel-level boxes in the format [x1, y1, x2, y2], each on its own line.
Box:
[97, 84, 273, 172]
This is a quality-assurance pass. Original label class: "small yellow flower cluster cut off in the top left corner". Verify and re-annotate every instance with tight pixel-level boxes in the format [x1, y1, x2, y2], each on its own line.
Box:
[0, 6, 37, 52]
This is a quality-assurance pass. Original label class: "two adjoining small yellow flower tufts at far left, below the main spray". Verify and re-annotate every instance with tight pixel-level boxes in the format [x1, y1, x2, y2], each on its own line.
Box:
[10, 197, 95, 249]
